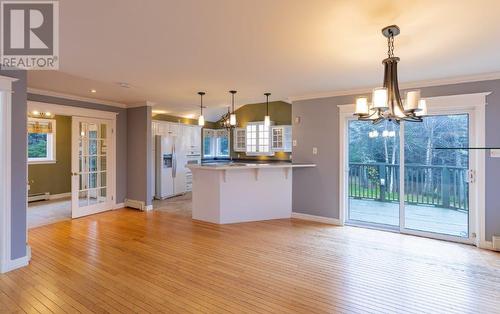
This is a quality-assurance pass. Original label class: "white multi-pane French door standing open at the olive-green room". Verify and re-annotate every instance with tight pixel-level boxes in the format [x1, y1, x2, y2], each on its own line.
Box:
[71, 117, 113, 218]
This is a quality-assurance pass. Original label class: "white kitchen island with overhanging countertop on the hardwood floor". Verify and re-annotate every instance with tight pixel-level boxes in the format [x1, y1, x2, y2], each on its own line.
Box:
[188, 163, 316, 224]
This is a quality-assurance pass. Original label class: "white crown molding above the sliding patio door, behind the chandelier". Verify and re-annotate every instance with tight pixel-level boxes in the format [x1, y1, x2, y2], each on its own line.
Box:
[288, 72, 500, 102]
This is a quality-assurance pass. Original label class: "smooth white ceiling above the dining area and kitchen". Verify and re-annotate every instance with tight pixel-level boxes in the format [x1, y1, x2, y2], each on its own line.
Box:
[28, 0, 500, 120]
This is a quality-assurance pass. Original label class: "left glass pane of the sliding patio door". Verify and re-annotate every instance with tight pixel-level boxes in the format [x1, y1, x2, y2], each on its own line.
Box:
[347, 120, 400, 229]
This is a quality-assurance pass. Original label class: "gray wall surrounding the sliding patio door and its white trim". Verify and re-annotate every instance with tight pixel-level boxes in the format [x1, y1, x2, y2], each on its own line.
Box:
[292, 80, 500, 241]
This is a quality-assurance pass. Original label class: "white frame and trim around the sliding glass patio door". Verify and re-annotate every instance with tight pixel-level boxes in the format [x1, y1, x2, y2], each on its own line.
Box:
[338, 92, 491, 247]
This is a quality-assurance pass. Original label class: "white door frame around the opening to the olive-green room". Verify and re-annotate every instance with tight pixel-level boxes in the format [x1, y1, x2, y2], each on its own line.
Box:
[28, 101, 118, 218]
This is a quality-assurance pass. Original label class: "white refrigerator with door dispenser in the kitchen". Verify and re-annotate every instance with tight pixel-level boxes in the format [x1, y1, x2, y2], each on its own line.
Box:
[155, 135, 187, 199]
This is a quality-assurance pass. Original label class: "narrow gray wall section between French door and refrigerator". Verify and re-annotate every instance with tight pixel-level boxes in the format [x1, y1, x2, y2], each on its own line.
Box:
[127, 106, 153, 205]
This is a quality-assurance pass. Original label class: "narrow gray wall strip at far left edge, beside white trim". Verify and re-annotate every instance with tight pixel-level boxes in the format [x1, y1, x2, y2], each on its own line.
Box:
[0, 69, 28, 260]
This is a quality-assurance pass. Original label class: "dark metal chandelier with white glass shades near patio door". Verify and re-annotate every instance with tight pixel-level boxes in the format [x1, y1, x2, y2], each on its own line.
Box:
[354, 25, 427, 124]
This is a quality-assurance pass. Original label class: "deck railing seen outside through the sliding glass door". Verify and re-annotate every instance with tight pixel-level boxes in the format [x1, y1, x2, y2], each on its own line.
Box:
[349, 163, 469, 210]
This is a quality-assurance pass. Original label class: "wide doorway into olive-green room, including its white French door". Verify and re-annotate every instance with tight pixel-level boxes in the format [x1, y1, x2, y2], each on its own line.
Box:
[27, 101, 116, 228]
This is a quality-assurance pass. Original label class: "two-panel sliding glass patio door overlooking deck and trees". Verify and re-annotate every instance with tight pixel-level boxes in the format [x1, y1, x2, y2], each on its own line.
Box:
[346, 111, 475, 242]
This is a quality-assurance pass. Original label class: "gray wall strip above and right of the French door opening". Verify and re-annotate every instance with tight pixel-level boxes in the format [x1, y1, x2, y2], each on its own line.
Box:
[28, 94, 127, 203]
